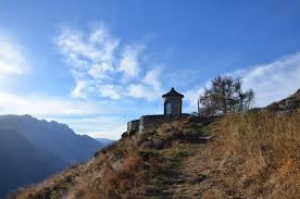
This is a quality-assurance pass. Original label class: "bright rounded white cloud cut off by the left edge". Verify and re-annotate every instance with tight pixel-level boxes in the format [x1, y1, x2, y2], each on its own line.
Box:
[0, 33, 28, 77]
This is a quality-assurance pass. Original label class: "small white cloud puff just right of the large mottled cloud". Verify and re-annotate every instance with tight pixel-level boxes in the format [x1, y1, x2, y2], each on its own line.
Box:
[118, 46, 143, 80]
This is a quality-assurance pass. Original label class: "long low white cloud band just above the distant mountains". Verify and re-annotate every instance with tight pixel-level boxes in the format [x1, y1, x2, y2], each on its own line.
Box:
[0, 88, 132, 139]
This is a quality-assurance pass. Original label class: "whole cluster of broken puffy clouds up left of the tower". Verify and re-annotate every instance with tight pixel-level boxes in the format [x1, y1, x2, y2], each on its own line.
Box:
[55, 25, 161, 100]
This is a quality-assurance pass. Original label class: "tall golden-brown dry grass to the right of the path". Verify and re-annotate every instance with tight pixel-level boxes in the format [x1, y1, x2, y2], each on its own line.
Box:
[214, 112, 300, 198]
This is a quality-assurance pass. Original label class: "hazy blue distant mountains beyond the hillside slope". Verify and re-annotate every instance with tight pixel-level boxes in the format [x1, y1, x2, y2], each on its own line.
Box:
[0, 115, 107, 198]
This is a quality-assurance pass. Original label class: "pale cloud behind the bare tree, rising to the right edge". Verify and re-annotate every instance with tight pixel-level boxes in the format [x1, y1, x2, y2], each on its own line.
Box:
[185, 53, 300, 110]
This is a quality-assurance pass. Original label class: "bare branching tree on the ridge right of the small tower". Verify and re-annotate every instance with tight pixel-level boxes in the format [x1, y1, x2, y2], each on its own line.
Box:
[198, 76, 254, 116]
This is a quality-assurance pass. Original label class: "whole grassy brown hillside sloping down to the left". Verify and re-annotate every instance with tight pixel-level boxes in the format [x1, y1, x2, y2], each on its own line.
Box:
[12, 113, 300, 199]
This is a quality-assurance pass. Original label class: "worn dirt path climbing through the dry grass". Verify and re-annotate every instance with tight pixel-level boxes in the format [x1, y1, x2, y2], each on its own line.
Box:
[164, 138, 224, 199]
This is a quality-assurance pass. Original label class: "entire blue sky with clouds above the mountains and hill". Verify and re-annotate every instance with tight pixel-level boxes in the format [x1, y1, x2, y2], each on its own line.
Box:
[0, 0, 300, 139]
